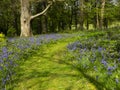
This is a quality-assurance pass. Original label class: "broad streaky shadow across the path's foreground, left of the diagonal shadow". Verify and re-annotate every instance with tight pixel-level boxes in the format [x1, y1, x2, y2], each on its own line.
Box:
[9, 69, 80, 90]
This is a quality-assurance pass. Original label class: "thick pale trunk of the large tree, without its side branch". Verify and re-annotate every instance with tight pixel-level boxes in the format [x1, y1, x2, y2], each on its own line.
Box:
[20, 0, 32, 37]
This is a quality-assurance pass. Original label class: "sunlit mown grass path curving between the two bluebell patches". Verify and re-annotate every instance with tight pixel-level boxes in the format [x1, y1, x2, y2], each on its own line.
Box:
[13, 40, 96, 90]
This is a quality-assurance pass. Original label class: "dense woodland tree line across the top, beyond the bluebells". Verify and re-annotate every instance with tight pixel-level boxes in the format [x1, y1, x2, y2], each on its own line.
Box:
[0, 0, 120, 37]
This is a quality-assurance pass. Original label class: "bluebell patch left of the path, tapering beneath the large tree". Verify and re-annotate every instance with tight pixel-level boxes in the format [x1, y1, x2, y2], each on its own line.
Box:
[0, 34, 71, 90]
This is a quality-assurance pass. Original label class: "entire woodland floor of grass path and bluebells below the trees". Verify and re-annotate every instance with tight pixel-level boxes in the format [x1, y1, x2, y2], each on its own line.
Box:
[0, 28, 120, 90]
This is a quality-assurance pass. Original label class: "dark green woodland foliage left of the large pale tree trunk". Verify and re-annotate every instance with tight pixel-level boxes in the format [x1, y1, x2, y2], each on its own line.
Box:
[0, 0, 20, 36]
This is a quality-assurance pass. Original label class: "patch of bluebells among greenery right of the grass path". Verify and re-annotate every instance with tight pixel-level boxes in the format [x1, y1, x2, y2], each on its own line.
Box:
[67, 40, 120, 89]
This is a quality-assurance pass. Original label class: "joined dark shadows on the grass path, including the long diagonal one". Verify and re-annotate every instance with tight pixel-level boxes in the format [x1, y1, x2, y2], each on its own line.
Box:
[9, 46, 120, 90]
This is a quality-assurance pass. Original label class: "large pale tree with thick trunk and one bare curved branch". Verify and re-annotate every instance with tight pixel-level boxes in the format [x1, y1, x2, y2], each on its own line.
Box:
[20, 0, 52, 37]
